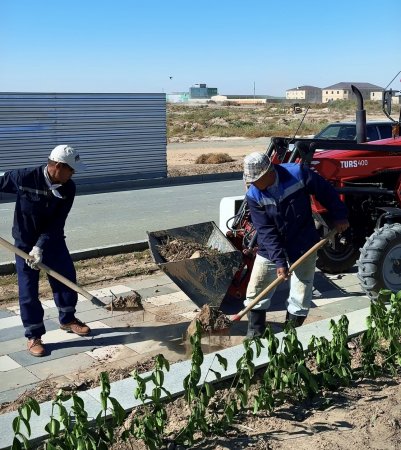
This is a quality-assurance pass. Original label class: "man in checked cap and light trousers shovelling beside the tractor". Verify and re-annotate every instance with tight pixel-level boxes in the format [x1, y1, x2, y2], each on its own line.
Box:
[244, 152, 349, 338]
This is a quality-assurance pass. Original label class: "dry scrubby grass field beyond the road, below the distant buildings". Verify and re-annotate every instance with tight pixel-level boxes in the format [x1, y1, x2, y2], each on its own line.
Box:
[167, 101, 384, 142]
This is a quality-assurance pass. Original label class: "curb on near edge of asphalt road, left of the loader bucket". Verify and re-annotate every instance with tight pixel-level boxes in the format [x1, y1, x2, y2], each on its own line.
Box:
[0, 241, 149, 275]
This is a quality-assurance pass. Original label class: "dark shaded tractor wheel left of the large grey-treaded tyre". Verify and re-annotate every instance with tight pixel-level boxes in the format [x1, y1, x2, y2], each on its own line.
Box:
[316, 230, 359, 273]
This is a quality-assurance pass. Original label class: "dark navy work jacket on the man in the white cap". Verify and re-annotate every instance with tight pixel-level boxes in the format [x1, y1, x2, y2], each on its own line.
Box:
[0, 166, 76, 249]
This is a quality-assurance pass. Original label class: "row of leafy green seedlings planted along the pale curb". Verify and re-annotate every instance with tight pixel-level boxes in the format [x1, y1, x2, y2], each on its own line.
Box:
[12, 291, 401, 450]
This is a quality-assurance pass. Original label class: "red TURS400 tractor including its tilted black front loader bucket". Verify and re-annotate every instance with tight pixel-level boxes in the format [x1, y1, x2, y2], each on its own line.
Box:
[148, 87, 401, 313]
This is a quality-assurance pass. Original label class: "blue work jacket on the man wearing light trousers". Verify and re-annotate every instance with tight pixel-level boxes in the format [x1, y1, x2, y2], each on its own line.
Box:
[246, 163, 347, 268]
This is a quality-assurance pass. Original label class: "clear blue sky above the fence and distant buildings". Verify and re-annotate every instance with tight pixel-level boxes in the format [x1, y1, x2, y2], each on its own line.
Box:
[0, 0, 401, 97]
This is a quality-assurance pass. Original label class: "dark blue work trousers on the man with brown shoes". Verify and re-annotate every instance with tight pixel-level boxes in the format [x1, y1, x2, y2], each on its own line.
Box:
[15, 240, 78, 339]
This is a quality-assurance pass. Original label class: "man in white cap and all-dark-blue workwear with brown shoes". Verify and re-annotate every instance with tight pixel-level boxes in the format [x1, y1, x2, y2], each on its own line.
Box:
[0, 145, 90, 356]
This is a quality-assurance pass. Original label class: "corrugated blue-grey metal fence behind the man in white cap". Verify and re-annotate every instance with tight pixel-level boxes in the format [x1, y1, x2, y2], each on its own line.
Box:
[0, 93, 167, 184]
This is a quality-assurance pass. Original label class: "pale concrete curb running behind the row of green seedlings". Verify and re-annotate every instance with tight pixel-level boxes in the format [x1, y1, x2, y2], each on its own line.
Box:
[0, 308, 370, 449]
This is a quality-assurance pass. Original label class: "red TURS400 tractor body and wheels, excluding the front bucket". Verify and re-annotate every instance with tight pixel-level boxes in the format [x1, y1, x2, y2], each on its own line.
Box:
[223, 87, 401, 299]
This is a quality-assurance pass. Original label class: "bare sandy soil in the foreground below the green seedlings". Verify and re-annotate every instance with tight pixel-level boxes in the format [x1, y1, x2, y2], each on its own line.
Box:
[108, 348, 401, 450]
